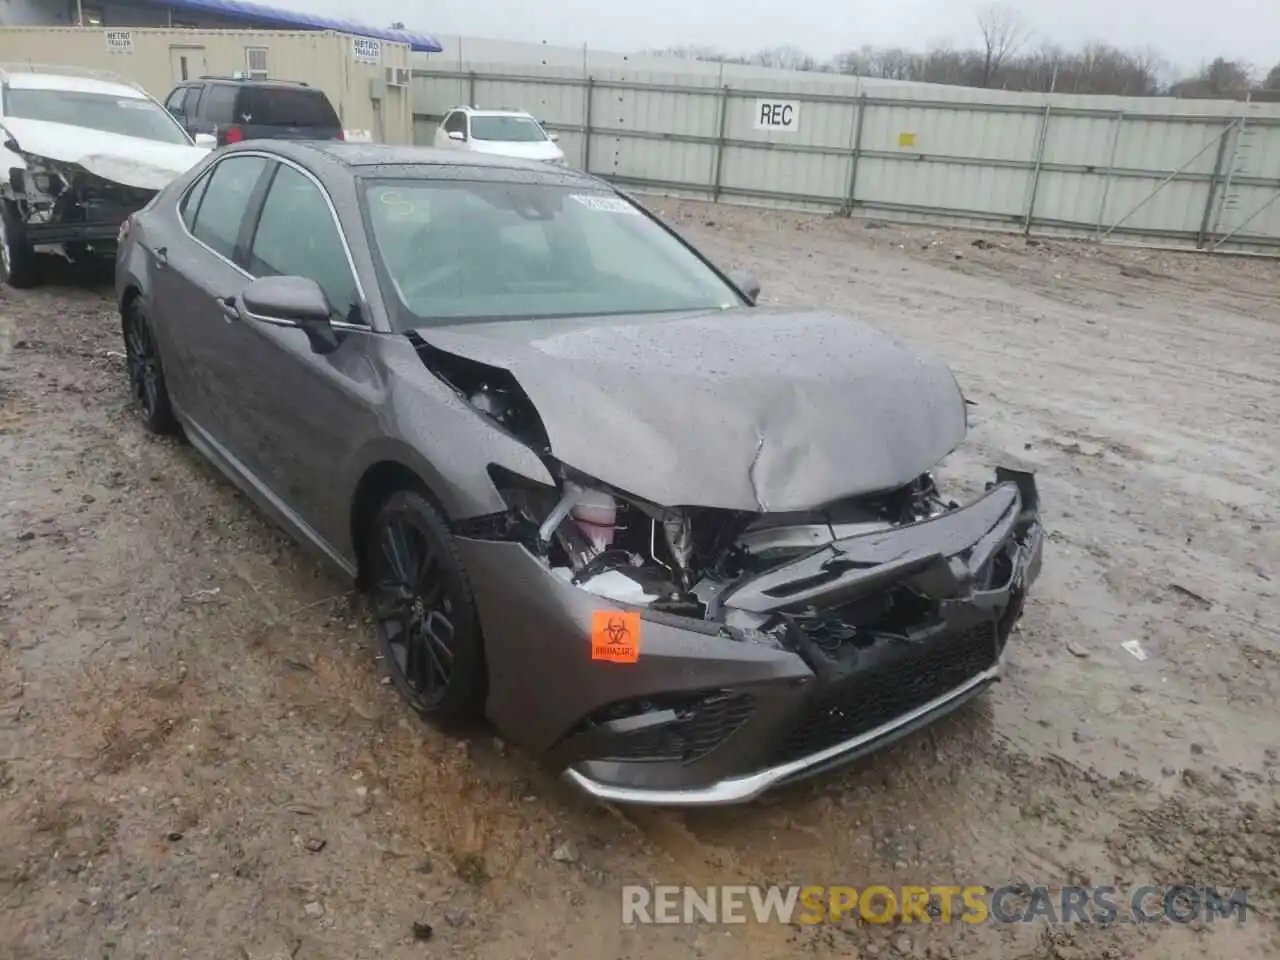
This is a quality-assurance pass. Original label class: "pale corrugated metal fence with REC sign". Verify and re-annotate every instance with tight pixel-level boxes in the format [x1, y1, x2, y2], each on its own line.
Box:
[413, 60, 1280, 255]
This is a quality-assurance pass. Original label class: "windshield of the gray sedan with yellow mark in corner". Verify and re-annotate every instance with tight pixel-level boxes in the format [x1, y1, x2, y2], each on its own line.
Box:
[364, 179, 742, 325]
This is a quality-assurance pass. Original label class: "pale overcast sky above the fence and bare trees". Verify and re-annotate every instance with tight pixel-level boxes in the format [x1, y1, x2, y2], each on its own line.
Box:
[296, 0, 1280, 69]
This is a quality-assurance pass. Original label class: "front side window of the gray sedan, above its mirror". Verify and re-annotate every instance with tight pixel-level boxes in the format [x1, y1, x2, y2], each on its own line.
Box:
[248, 164, 364, 323]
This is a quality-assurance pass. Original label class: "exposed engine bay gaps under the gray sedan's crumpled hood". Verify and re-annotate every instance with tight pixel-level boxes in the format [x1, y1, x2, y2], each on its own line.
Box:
[416, 340, 1012, 649]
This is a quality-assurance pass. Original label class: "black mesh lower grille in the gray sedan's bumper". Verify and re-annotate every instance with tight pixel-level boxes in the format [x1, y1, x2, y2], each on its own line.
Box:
[774, 626, 997, 763]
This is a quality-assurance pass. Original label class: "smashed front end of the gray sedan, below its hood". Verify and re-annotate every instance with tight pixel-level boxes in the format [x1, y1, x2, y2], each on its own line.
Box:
[416, 330, 1043, 805]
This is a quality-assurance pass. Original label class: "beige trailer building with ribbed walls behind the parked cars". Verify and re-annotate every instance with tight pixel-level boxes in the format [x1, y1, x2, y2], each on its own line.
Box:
[0, 27, 413, 143]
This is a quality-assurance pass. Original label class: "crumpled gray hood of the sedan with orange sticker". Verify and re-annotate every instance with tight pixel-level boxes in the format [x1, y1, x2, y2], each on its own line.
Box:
[416, 307, 965, 512]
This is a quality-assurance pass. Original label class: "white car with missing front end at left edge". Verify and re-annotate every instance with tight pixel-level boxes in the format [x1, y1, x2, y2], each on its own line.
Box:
[0, 64, 212, 287]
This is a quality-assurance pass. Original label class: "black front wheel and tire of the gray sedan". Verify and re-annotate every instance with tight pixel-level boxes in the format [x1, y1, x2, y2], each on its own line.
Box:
[365, 490, 484, 723]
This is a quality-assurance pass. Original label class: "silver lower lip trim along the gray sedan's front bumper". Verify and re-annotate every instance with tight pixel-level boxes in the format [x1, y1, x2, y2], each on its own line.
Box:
[563, 662, 1001, 806]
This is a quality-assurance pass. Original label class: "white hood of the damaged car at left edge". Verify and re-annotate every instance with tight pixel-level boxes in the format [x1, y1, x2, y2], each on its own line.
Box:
[0, 116, 209, 191]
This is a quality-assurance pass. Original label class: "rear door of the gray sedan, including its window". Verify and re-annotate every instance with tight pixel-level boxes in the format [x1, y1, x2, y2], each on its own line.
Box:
[151, 154, 270, 448]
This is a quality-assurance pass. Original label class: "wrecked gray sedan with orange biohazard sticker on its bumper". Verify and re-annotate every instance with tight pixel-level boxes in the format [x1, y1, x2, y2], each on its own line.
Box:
[116, 141, 1043, 805]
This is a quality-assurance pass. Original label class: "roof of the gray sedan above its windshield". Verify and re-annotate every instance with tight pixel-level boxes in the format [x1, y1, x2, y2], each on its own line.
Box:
[248, 140, 599, 189]
